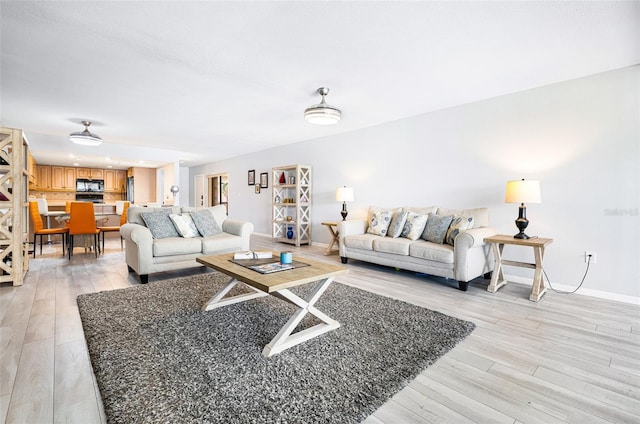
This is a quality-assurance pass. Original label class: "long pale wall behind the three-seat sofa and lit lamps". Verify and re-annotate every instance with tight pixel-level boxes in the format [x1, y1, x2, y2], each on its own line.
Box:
[190, 66, 640, 300]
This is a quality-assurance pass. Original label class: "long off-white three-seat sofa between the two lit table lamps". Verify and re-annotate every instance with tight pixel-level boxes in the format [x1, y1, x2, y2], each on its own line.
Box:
[338, 206, 498, 291]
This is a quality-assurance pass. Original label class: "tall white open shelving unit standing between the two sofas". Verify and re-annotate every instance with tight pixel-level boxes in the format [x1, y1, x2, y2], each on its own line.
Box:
[271, 165, 311, 246]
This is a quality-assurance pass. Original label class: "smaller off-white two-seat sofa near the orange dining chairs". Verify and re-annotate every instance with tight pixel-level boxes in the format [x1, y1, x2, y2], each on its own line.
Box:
[120, 205, 253, 284]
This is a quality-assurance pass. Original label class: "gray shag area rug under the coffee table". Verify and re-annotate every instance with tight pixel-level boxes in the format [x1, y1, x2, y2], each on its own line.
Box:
[78, 272, 474, 424]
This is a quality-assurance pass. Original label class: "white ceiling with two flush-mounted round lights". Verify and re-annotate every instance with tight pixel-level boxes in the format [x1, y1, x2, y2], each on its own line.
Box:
[0, 0, 640, 168]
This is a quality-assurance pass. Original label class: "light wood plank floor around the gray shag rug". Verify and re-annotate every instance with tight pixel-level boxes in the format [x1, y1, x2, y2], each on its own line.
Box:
[0, 236, 640, 424]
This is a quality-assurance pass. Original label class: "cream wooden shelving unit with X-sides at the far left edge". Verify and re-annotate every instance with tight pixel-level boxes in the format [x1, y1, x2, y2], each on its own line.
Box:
[0, 127, 29, 286]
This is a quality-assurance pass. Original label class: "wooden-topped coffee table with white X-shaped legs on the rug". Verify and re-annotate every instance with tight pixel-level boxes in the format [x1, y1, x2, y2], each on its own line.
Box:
[196, 253, 349, 356]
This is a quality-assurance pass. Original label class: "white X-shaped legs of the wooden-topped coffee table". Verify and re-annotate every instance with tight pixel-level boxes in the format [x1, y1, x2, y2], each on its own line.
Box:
[202, 277, 340, 357]
